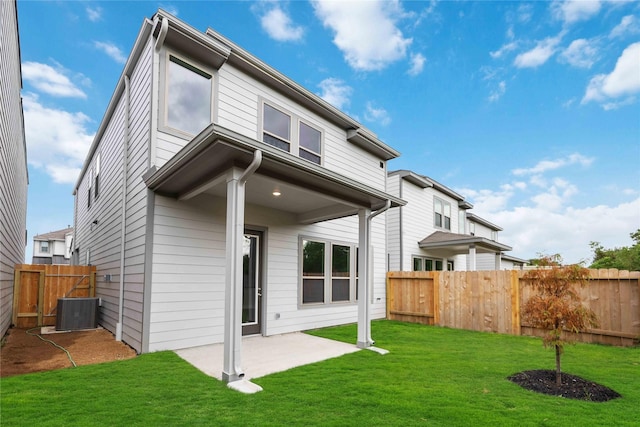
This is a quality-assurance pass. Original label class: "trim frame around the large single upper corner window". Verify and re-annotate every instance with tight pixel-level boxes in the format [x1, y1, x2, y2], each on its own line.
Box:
[158, 46, 218, 140]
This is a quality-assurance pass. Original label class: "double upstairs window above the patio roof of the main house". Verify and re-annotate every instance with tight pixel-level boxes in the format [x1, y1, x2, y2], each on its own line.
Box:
[262, 102, 322, 165]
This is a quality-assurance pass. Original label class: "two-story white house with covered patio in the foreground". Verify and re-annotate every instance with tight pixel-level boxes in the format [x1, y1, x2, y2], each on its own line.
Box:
[72, 10, 404, 382]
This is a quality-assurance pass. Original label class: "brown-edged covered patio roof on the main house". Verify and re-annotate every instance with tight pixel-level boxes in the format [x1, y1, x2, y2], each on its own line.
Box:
[143, 124, 406, 224]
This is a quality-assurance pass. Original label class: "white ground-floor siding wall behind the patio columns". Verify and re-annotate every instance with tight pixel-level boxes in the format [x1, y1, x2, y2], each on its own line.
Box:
[149, 195, 386, 351]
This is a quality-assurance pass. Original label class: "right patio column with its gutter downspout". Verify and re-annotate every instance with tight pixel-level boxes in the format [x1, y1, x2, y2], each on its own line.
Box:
[357, 200, 391, 354]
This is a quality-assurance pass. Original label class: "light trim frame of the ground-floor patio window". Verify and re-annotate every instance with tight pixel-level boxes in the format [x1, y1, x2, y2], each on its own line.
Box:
[298, 235, 358, 309]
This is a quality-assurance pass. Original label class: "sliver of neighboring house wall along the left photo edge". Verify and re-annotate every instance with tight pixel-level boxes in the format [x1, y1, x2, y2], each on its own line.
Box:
[0, 1, 29, 337]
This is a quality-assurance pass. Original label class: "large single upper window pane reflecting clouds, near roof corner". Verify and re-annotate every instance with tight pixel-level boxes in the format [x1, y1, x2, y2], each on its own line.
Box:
[165, 56, 212, 135]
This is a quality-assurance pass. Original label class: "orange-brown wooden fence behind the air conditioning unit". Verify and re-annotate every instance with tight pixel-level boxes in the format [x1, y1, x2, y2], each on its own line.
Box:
[12, 264, 96, 328]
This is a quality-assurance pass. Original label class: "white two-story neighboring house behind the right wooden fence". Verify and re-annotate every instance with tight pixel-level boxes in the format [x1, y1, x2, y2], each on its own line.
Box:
[387, 170, 511, 271]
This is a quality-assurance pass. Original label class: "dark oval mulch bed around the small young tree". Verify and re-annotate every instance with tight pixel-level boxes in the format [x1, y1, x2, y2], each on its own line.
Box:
[507, 369, 620, 402]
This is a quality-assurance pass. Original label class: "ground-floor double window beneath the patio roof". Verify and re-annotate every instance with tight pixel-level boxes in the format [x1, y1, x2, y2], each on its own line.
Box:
[301, 239, 358, 304]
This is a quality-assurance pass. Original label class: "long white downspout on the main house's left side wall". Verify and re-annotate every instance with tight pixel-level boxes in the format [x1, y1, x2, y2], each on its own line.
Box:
[116, 75, 131, 341]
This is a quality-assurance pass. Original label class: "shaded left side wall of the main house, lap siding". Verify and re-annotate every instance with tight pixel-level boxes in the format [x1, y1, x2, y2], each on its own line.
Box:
[74, 36, 152, 352]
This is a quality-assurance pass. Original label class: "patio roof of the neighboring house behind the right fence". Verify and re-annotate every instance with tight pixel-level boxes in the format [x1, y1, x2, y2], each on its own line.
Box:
[418, 231, 512, 258]
